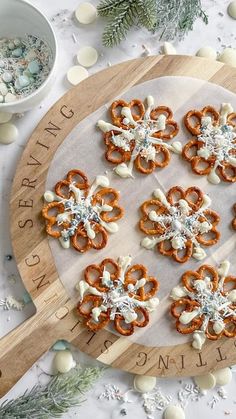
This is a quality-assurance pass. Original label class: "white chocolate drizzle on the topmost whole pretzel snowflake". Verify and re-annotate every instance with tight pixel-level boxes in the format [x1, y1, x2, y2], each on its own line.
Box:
[97, 96, 182, 178]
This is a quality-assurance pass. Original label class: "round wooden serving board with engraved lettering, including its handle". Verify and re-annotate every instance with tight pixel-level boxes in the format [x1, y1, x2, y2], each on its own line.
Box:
[0, 56, 236, 396]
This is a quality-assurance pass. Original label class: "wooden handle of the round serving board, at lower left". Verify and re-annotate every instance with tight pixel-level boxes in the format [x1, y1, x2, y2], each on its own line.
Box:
[0, 306, 60, 397]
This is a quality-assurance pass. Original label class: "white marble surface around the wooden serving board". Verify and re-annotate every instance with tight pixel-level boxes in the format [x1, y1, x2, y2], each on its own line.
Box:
[0, 0, 236, 419]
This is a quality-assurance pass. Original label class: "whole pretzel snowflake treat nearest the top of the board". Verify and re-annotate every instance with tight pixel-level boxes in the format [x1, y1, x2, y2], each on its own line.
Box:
[98, 96, 182, 178]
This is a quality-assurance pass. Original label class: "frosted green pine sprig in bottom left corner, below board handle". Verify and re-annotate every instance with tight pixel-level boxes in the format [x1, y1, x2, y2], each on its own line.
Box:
[0, 367, 103, 419]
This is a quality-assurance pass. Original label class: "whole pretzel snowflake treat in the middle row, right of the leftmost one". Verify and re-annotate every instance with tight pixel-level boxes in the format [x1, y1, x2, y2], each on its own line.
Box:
[139, 186, 220, 263]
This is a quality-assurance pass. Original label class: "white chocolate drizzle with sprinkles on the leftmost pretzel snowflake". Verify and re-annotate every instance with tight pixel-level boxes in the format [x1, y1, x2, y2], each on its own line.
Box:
[44, 175, 119, 249]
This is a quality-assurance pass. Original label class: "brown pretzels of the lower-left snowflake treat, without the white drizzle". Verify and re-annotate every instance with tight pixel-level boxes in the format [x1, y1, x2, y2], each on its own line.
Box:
[77, 258, 159, 336]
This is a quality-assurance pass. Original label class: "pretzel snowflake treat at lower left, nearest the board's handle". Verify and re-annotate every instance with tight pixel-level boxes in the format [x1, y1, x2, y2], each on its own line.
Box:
[77, 256, 159, 336]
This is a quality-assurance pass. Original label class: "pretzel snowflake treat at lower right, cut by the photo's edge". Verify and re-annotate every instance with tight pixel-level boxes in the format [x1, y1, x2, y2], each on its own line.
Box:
[170, 261, 236, 350]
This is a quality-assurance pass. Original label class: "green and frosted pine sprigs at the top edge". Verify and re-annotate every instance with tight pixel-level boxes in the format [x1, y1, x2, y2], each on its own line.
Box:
[98, 0, 208, 47]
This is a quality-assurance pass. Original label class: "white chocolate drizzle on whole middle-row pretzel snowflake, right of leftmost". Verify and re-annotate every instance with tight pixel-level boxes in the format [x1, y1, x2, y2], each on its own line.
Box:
[141, 189, 212, 260]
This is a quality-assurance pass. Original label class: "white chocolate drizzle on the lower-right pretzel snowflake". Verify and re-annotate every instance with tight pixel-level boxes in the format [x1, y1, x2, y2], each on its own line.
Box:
[170, 261, 236, 350]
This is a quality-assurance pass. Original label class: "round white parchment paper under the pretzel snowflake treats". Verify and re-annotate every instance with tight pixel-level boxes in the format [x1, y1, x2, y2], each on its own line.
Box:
[47, 77, 236, 346]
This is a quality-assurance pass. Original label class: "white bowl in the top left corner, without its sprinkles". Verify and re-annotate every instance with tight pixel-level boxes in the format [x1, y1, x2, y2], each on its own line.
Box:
[0, 0, 58, 113]
